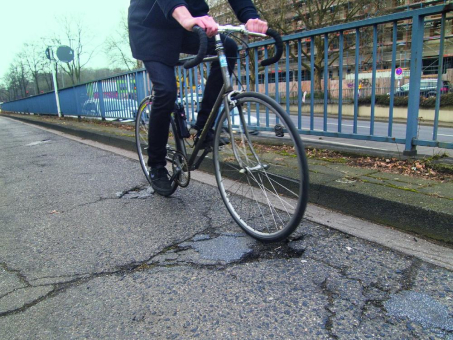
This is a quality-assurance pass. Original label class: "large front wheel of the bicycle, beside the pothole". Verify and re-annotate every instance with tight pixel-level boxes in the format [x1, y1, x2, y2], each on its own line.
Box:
[214, 92, 308, 242]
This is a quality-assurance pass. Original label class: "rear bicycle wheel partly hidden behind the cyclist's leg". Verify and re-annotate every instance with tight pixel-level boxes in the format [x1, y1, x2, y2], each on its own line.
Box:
[135, 96, 184, 195]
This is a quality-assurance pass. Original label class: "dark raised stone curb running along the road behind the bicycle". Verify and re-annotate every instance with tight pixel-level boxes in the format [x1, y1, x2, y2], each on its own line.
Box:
[8, 116, 453, 244]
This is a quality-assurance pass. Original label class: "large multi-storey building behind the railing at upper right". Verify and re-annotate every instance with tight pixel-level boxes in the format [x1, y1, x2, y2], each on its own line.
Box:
[208, 0, 453, 82]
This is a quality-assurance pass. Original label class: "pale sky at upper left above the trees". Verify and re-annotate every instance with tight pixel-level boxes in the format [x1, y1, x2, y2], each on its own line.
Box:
[0, 0, 130, 82]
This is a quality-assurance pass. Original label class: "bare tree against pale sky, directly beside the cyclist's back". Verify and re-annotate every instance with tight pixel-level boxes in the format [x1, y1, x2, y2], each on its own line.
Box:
[104, 15, 143, 71]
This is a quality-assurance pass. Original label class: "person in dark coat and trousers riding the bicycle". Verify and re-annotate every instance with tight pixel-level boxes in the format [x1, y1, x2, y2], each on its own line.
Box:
[128, 0, 267, 196]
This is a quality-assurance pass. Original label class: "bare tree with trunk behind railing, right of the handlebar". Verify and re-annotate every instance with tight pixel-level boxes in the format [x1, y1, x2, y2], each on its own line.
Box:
[209, 0, 387, 90]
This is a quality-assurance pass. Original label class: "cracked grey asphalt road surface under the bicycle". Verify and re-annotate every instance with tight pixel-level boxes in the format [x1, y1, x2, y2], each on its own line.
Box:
[0, 118, 453, 339]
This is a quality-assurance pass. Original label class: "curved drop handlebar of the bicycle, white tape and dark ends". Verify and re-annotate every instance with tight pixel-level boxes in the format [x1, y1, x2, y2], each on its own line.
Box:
[184, 25, 283, 69]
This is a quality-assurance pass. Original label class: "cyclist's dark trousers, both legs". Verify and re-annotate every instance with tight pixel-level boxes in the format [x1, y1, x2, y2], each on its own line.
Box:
[143, 32, 237, 167]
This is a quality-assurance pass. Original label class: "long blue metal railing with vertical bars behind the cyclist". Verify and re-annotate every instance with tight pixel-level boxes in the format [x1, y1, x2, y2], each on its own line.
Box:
[2, 5, 453, 155]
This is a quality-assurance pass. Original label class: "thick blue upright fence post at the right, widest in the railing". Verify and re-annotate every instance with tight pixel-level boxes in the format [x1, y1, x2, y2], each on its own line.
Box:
[403, 15, 425, 156]
